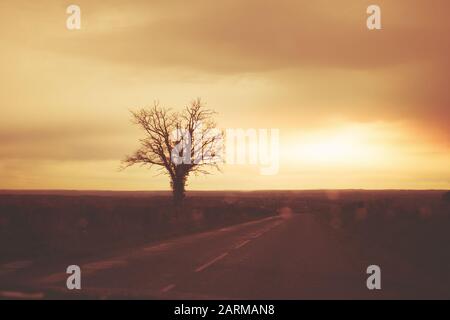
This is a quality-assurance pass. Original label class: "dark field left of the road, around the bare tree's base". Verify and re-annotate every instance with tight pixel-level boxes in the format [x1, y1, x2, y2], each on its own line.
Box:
[0, 191, 280, 261]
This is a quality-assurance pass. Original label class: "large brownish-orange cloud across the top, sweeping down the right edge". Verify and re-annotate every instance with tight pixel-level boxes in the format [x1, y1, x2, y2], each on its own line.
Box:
[33, 0, 450, 135]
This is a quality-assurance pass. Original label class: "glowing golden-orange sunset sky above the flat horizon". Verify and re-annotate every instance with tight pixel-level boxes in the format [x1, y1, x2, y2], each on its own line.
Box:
[0, 0, 450, 190]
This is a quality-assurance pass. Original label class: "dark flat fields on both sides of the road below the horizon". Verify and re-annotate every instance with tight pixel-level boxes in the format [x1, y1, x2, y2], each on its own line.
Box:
[0, 190, 450, 297]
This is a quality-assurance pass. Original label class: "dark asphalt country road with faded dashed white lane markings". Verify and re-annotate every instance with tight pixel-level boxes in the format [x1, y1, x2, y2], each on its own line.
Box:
[0, 214, 444, 299]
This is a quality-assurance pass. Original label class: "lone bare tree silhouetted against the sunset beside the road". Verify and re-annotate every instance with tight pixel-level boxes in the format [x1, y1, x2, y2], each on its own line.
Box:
[123, 99, 221, 206]
